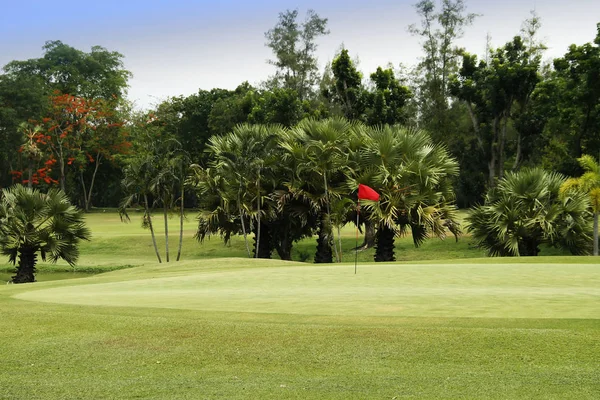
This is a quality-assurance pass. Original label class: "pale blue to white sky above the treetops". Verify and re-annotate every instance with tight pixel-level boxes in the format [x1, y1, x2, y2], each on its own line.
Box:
[0, 0, 600, 108]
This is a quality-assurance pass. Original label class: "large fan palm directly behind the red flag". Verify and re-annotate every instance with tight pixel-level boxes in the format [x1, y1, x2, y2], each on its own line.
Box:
[349, 126, 458, 261]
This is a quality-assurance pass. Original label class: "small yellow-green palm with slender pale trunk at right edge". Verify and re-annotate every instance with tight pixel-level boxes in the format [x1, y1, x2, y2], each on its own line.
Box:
[560, 155, 600, 256]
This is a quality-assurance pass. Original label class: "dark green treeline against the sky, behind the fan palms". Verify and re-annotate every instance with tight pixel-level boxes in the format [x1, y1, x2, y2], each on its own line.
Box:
[0, 0, 600, 255]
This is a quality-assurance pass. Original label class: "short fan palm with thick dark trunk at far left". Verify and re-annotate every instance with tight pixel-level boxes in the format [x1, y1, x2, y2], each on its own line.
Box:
[0, 185, 91, 283]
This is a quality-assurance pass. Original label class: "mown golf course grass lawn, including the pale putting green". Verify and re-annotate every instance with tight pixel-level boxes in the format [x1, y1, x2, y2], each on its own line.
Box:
[0, 214, 600, 399]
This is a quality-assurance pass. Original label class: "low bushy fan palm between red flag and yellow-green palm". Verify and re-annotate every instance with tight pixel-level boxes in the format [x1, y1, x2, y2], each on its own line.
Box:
[467, 168, 591, 256]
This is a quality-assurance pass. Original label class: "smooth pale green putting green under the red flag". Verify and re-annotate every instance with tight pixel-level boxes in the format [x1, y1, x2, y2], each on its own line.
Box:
[15, 260, 600, 318]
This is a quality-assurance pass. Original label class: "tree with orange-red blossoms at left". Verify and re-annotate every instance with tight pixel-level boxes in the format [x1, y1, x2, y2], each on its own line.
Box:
[12, 93, 130, 210]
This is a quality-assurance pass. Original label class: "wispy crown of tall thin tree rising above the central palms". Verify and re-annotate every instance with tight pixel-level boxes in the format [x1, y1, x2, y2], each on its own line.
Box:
[265, 10, 329, 100]
